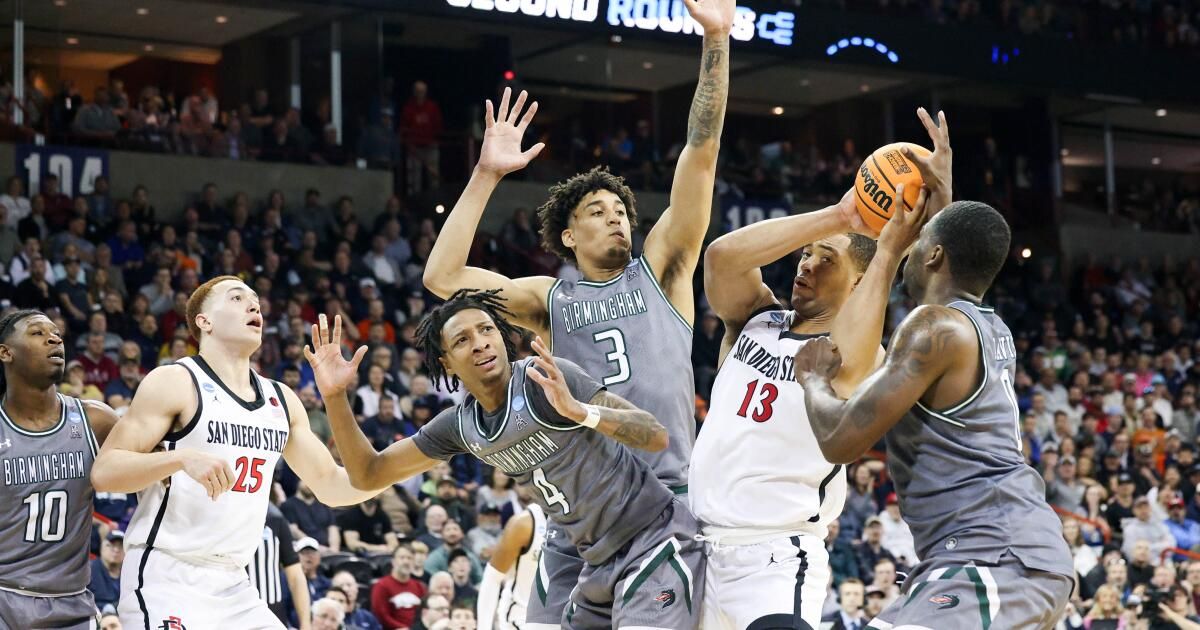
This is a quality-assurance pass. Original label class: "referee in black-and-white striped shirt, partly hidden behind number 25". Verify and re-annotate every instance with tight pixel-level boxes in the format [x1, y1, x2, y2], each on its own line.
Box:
[246, 504, 312, 628]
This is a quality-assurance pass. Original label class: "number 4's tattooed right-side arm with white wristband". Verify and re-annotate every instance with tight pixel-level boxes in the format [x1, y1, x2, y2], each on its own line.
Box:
[526, 337, 670, 452]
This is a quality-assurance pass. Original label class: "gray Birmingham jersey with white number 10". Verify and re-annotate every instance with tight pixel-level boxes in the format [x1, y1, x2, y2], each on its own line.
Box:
[0, 395, 100, 595]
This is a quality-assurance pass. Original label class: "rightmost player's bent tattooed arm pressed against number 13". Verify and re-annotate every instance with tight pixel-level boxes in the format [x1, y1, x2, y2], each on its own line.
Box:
[796, 305, 979, 464]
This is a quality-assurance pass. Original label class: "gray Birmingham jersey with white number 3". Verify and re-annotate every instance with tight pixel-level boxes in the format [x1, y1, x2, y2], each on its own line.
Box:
[546, 258, 696, 487]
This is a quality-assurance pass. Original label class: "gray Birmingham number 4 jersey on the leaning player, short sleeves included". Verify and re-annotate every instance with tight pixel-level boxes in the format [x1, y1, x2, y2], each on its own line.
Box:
[413, 359, 673, 564]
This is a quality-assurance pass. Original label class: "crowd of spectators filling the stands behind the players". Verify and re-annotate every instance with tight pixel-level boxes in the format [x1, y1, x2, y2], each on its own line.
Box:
[0, 75, 1200, 630]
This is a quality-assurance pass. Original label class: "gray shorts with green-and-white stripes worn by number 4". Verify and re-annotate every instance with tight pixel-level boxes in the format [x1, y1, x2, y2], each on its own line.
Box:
[562, 498, 704, 630]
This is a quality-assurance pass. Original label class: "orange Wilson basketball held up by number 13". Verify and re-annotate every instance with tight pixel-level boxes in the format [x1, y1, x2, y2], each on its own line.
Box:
[854, 142, 930, 232]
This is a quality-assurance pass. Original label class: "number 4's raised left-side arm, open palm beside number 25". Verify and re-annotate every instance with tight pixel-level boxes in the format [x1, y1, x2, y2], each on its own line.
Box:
[302, 314, 438, 489]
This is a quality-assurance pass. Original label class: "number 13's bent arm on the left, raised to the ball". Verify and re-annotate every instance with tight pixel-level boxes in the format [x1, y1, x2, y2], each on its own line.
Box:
[704, 191, 868, 361]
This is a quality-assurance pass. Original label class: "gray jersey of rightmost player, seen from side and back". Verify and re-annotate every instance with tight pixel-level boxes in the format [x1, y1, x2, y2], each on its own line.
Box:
[887, 300, 1074, 576]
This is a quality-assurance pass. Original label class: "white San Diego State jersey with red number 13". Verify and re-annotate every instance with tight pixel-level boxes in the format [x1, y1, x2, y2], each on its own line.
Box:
[688, 308, 846, 541]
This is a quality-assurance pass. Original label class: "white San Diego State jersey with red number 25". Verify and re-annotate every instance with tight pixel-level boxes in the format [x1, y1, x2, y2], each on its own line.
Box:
[125, 355, 289, 569]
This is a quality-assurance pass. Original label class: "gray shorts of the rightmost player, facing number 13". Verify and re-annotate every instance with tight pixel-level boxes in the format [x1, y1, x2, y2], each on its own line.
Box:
[866, 553, 1073, 630]
